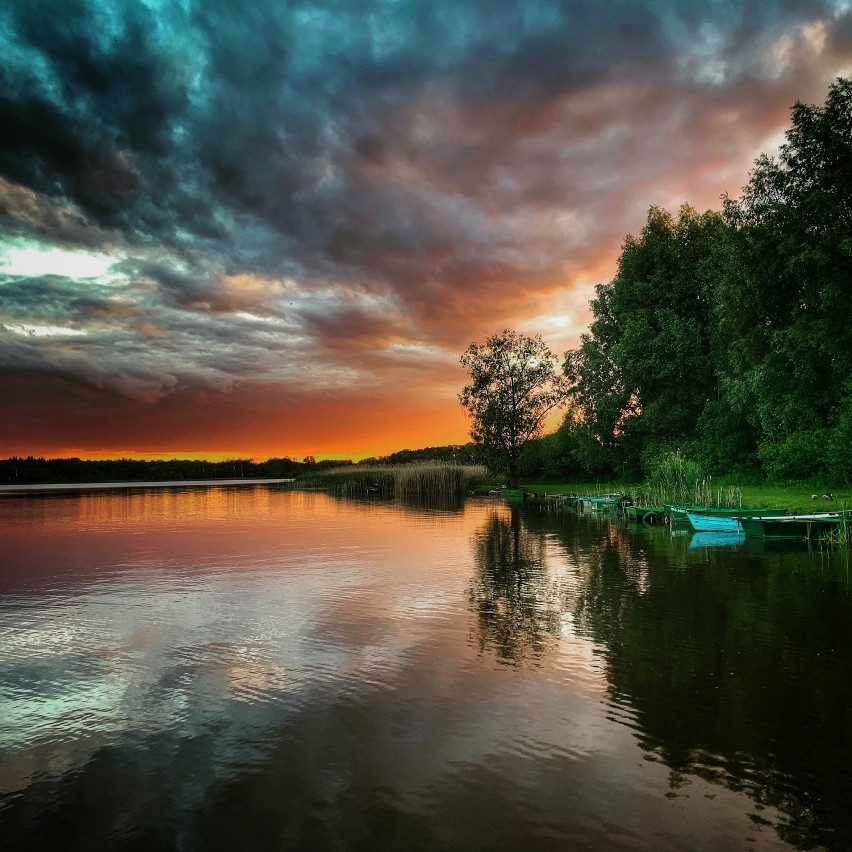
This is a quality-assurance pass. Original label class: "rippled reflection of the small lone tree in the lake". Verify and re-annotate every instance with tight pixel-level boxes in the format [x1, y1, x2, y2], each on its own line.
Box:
[469, 506, 562, 665]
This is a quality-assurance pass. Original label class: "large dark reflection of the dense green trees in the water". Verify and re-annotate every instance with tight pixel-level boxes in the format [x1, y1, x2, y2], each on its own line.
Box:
[520, 510, 852, 849]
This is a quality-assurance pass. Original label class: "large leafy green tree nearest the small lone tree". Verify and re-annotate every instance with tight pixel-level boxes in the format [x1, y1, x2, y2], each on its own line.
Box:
[565, 205, 725, 476]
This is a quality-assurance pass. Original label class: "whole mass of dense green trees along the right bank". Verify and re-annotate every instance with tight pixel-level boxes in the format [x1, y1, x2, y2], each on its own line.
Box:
[521, 78, 852, 485]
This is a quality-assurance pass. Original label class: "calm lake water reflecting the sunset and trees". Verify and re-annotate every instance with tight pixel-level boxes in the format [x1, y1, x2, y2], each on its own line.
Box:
[0, 486, 852, 850]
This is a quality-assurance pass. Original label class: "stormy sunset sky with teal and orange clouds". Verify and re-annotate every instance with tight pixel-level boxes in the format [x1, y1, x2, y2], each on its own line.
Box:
[0, 0, 852, 459]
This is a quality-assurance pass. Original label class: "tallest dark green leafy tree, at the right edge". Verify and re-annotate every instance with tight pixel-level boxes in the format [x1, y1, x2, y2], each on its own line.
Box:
[716, 79, 852, 479]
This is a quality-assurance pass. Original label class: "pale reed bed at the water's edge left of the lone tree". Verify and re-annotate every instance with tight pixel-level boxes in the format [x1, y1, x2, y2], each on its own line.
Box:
[302, 462, 486, 498]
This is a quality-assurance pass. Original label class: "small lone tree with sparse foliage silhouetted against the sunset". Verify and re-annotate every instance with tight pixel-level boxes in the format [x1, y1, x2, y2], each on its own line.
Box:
[459, 329, 570, 487]
